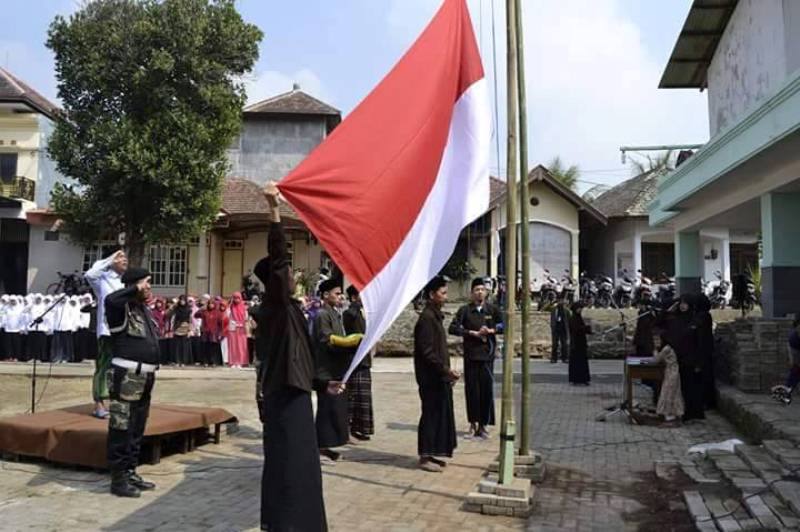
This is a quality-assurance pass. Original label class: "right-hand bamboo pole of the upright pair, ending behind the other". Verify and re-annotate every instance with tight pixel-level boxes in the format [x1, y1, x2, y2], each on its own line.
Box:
[515, 0, 531, 456]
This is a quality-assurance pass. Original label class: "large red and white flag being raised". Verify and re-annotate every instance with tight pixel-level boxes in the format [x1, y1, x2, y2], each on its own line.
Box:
[278, 0, 492, 380]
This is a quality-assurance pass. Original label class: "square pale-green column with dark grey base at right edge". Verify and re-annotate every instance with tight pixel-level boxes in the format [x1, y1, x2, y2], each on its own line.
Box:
[761, 192, 800, 318]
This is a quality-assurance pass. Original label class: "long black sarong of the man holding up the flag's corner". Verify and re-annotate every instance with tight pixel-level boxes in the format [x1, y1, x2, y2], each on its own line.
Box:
[261, 388, 328, 532]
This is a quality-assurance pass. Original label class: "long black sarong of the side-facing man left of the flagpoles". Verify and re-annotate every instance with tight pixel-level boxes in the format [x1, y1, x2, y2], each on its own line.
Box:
[417, 382, 456, 457]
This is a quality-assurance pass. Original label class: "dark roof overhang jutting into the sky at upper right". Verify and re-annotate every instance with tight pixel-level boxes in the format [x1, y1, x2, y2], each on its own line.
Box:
[659, 0, 738, 89]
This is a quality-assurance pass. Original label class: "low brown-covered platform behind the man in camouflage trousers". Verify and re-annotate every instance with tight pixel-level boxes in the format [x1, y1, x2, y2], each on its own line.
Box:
[0, 404, 237, 469]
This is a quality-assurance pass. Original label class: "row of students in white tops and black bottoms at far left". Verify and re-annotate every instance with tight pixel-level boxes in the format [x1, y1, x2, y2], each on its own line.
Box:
[0, 294, 97, 362]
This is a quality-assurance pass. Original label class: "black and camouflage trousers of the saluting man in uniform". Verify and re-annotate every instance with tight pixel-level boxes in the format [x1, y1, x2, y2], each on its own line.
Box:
[108, 366, 155, 473]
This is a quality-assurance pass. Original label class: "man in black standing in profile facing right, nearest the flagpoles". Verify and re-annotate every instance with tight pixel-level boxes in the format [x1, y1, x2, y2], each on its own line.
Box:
[414, 276, 461, 473]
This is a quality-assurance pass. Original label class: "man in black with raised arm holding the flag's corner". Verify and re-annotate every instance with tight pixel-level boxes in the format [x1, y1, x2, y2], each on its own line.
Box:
[253, 183, 344, 532]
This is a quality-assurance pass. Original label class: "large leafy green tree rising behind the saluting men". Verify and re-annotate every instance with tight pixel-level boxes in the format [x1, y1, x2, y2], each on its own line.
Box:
[47, 0, 262, 264]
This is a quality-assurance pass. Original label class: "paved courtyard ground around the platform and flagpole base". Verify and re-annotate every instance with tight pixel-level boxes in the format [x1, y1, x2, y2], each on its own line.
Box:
[0, 359, 736, 531]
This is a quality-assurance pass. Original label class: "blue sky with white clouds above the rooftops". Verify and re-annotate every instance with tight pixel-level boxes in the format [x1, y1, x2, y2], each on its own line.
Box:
[0, 0, 708, 189]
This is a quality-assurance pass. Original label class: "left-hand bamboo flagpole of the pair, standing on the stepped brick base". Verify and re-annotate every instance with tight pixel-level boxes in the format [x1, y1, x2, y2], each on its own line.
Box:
[498, 0, 518, 484]
